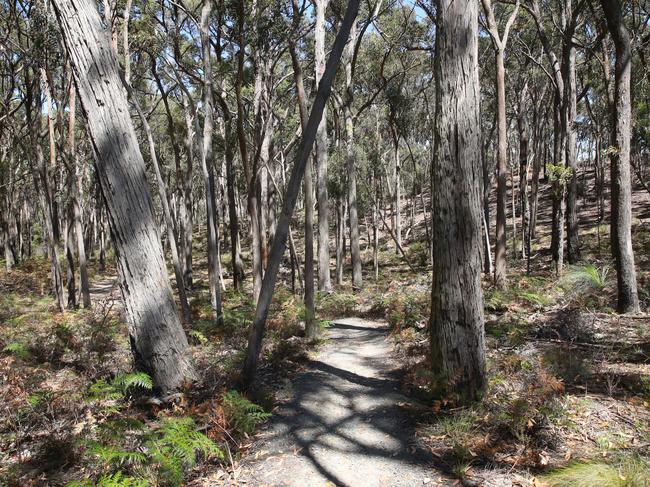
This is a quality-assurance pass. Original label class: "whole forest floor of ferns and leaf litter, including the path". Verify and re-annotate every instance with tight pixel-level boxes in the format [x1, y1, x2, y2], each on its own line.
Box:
[0, 173, 650, 487]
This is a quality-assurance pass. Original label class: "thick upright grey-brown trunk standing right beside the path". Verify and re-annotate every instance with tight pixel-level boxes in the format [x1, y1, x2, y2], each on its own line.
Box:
[429, 0, 486, 400]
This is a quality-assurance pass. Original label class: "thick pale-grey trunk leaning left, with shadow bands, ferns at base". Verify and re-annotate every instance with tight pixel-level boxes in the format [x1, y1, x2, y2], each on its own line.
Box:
[53, 0, 194, 393]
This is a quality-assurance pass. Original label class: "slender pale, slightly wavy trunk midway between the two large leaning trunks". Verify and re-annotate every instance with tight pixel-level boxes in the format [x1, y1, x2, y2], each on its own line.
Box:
[200, 0, 223, 325]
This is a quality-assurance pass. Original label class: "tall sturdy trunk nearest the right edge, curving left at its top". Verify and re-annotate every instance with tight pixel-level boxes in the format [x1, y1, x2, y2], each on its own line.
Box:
[600, 0, 639, 313]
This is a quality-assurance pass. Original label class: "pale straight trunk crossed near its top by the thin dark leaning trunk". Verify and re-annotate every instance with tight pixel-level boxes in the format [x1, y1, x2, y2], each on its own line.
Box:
[314, 0, 332, 292]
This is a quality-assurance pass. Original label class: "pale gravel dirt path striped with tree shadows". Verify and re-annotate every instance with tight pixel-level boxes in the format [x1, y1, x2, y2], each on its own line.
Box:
[233, 319, 452, 487]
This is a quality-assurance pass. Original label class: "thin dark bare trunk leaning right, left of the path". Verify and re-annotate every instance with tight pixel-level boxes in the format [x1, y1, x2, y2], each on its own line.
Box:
[242, 0, 360, 383]
